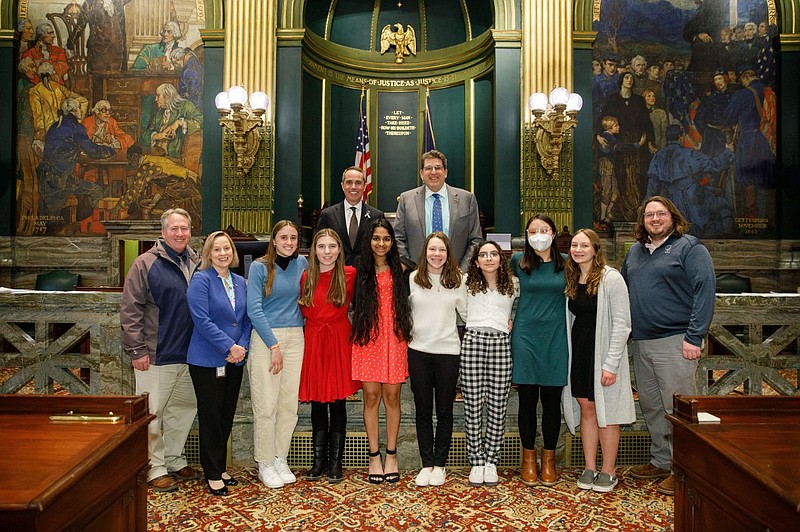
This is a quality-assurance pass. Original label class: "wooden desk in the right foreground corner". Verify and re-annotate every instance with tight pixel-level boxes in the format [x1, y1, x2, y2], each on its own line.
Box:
[667, 395, 800, 532]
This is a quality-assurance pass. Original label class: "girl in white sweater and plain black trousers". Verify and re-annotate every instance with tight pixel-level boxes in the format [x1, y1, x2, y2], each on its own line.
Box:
[408, 231, 467, 486]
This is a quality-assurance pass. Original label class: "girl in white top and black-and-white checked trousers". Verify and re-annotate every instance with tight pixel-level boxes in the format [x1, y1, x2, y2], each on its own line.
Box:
[461, 240, 519, 486]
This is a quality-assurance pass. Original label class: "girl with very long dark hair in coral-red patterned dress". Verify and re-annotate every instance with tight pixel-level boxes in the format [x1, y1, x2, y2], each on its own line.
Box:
[353, 218, 411, 484]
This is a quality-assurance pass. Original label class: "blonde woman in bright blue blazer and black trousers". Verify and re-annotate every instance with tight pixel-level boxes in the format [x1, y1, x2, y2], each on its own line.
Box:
[186, 231, 251, 496]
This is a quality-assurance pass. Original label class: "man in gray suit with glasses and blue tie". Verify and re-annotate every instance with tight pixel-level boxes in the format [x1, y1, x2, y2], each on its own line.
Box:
[394, 150, 482, 271]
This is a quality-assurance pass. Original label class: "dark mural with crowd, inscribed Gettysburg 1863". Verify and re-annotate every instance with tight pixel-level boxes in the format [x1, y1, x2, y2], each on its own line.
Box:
[592, 0, 778, 238]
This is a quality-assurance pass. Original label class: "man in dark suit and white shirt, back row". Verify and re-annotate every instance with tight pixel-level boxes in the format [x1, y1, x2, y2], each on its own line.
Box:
[316, 166, 383, 266]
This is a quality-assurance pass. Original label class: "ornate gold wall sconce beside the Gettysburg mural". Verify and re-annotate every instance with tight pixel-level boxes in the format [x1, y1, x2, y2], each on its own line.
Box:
[528, 87, 583, 179]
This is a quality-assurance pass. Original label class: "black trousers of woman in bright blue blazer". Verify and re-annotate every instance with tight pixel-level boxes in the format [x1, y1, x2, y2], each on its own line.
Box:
[189, 364, 244, 480]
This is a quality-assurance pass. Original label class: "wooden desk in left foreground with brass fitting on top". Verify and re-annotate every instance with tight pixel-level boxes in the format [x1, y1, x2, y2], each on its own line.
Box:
[0, 395, 154, 532]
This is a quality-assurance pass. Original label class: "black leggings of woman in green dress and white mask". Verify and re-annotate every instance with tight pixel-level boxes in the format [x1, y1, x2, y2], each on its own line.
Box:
[517, 384, 564, 451]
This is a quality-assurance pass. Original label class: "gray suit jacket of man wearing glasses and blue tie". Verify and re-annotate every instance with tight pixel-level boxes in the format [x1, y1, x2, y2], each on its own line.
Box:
[394, 184, 483, 272]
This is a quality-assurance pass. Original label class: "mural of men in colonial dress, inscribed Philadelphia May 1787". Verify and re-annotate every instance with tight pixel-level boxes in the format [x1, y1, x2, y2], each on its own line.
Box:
[16, 0, 205, 236]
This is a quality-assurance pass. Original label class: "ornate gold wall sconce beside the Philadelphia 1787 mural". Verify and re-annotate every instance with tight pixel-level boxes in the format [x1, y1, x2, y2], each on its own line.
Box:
[214, 86, 269, 177]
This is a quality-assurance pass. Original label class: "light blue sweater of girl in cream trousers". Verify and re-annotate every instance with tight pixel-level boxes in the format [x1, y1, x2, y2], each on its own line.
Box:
[247, 255, 308, 346]
